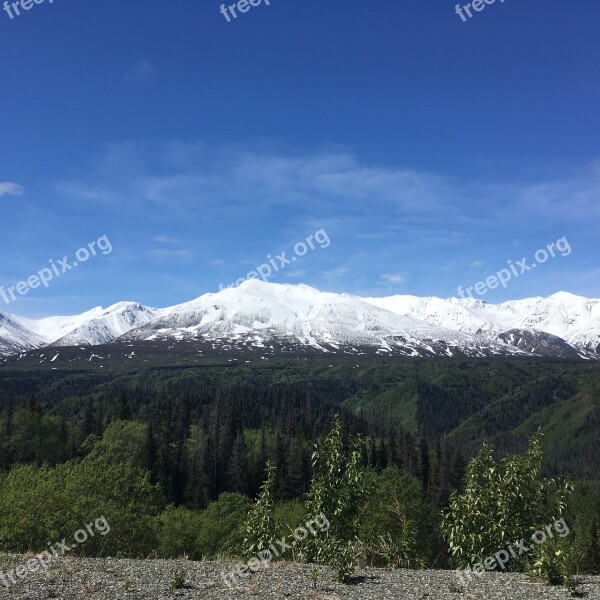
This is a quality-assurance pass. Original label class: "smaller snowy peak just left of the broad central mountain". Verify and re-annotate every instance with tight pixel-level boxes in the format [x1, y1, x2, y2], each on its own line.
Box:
[17, 302, 161, 346]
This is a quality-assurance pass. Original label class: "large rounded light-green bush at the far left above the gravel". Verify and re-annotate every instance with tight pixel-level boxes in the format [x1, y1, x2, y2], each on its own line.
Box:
[0, 457, 163, 557]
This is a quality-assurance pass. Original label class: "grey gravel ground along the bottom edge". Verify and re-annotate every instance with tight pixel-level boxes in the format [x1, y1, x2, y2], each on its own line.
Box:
[0, 555, 600, 600]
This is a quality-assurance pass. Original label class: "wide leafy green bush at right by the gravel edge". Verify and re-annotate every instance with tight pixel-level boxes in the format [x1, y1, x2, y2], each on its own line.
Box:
[442, 432, 573, 570]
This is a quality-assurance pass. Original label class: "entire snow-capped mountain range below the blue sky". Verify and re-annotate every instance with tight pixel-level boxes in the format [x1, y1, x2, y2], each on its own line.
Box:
[0, 280, 600, 358]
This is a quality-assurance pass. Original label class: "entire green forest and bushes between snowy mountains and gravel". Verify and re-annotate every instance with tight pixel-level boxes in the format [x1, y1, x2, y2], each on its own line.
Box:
[0, 357, 600, 582]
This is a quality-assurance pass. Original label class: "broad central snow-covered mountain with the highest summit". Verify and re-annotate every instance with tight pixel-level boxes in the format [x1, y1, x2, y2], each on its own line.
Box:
[121, 280, 514, 355]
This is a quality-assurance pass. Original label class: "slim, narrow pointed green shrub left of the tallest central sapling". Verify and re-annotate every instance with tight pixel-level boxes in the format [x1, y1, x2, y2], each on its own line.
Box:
[244, 461, 279, 558]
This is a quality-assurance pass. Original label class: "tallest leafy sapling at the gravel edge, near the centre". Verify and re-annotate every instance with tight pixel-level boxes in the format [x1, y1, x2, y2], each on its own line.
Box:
[303, 417, 365, 582]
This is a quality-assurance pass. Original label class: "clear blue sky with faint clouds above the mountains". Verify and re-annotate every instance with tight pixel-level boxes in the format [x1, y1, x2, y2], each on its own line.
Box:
[0, 0, 600, 316]
